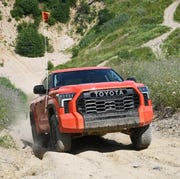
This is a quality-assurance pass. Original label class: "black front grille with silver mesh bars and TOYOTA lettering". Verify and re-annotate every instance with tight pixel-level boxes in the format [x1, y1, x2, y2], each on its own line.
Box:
[77, 88, 139, 114]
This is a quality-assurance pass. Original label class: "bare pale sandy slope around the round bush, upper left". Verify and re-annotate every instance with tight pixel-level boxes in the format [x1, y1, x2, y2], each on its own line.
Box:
[0, 0, 74, 95]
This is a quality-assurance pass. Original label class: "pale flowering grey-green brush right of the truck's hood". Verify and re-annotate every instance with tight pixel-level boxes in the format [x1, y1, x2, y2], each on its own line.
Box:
[108, 58, 180, 110]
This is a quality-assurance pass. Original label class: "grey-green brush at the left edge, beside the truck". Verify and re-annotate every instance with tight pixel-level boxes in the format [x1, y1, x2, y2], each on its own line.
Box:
[0, 77, 27, 148]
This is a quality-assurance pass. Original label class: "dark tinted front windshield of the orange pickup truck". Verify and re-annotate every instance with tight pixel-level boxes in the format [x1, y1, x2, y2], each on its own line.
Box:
[53, 69, 123, 87]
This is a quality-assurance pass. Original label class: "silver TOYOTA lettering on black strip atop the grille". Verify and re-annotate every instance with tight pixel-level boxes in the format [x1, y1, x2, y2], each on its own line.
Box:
[92, 89, 127, 98]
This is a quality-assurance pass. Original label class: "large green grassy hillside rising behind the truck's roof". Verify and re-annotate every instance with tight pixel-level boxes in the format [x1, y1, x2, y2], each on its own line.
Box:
[56, 0, 173, 68]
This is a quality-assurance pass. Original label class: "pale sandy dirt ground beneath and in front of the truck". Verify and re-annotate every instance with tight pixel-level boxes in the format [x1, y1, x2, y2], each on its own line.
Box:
[0, 129, 180, 179]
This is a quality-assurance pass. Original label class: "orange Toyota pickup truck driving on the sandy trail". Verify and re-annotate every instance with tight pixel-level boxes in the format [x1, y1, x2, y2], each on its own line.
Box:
[30, 67, 153, 152]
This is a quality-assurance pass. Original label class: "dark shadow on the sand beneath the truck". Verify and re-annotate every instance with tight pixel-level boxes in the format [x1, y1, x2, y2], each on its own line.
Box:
[21, 136, 133, 159]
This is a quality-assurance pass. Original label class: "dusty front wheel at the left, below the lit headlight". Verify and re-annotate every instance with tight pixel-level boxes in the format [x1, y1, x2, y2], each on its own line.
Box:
[50, 115, 71, 152]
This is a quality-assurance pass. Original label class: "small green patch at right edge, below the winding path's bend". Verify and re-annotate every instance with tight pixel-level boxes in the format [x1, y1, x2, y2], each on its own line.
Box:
[163, 28, 180, 57]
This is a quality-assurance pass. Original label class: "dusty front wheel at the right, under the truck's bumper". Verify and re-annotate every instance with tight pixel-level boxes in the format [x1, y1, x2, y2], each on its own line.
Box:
[130, 125, 152, 150]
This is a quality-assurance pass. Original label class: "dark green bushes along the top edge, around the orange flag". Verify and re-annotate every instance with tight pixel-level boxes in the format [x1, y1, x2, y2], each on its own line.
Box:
[11, 0, 76, 25]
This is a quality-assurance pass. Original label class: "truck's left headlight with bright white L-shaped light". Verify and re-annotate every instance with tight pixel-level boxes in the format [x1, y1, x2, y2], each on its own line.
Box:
[56, 93, 75, 107]
